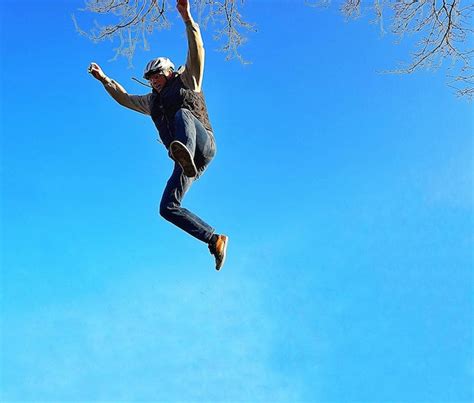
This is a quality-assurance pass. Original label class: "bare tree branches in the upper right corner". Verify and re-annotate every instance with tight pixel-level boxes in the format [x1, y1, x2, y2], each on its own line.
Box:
[311, 0, 474, 99]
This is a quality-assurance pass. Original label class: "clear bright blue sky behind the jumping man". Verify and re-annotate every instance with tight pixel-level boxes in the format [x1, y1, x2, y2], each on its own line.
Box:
[0, 0, 474, 403]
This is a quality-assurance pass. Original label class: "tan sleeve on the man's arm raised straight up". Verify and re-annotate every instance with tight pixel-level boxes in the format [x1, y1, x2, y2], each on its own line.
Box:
[181, 21, 204, 92]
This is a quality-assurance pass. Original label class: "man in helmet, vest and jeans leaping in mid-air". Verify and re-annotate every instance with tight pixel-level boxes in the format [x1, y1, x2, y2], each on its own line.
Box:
[89, 0, 228, 270]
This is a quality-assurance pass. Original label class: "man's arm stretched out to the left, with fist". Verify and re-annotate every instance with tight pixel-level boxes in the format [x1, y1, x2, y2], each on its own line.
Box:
[89, 63, 150, 115]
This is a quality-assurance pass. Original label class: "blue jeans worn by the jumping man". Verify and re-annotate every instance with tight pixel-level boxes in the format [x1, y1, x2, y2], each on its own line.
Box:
[160, 109, 216, 243]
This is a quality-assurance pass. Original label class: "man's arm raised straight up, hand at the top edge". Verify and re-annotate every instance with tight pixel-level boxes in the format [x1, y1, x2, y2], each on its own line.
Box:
[176, 0, 204, 92]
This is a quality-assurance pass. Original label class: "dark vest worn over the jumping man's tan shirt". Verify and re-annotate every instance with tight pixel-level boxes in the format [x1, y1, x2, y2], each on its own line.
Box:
[150, 74, 212, 148]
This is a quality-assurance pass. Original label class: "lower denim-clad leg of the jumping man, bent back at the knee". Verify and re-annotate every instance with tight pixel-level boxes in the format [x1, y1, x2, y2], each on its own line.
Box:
[160, 163, 215, 243]
